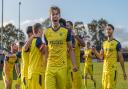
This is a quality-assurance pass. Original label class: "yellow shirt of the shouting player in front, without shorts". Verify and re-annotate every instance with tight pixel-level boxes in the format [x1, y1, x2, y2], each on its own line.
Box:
[44, 27, 71, 67]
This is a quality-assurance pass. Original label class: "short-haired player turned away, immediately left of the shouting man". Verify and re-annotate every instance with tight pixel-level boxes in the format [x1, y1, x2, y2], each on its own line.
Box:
[24, 23, 45, 89]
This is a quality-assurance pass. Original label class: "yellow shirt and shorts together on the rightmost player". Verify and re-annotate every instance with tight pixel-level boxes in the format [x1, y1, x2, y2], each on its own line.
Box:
[102, 39, 121, 89]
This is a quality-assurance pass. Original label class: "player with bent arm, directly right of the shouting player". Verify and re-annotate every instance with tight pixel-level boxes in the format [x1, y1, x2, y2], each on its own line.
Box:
[66, 21, 85, 89]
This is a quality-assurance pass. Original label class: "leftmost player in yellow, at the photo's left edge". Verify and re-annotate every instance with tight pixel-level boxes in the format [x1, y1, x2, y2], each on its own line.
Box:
[3, 43, 18, 89]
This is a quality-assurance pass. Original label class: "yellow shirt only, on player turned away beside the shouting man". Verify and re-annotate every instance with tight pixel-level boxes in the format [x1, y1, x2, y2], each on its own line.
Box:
[28, 38, 45, 79]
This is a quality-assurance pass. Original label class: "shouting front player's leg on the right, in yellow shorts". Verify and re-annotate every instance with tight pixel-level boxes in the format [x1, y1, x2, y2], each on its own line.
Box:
[56, 67, 67, 89]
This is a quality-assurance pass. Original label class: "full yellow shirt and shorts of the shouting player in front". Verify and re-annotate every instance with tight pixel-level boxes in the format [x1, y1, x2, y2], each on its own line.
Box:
[44, 27, 71, 89]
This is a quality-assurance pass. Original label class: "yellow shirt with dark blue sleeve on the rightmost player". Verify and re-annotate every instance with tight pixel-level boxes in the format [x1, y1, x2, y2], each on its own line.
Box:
[103, 39, 121, 72]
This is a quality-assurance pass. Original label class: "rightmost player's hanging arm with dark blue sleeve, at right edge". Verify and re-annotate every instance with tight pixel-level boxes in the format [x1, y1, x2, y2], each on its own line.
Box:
[117, 43, 127, 80]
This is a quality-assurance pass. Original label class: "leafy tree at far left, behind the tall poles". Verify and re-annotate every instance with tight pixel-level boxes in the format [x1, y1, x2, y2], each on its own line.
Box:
[0, 23, 25, 49]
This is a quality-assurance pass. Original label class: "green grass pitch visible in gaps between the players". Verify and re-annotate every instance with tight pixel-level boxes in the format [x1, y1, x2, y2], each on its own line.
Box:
[0, 62, 128, 89]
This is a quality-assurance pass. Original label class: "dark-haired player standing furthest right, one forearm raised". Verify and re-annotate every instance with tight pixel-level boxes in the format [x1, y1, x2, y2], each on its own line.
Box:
[93, 24, 127, 89]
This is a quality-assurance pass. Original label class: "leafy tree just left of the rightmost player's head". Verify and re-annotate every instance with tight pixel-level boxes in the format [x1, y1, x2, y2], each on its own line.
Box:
[88, 18, 108, 50]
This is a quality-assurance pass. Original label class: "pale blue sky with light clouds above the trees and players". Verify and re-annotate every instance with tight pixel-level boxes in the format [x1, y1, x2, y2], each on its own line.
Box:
[0, 0, 128, 45]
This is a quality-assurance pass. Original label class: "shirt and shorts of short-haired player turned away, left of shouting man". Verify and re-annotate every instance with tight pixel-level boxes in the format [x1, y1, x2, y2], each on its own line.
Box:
[28, 37, 45, 89]
